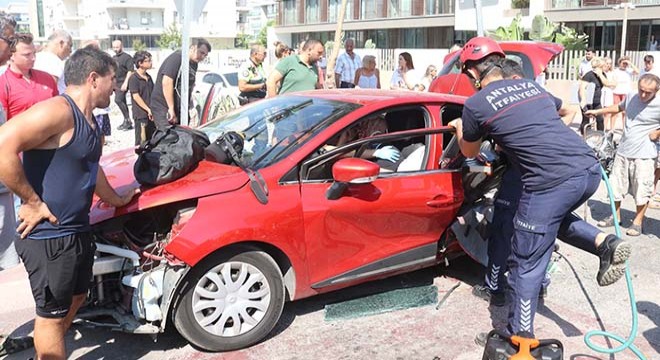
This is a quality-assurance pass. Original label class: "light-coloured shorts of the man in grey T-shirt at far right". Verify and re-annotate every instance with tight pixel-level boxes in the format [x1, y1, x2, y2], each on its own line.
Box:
[610, 155, 656, 206]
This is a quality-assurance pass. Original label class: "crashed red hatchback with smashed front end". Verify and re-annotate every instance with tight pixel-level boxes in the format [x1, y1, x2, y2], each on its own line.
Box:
[80, 90, 496, 351]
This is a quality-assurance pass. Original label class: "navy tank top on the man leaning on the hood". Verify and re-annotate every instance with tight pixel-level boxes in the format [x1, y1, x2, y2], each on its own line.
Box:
[23, 94, 101, 239]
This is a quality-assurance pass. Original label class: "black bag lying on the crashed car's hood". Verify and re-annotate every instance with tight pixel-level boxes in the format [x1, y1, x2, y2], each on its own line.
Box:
[133, 125, 210, 185]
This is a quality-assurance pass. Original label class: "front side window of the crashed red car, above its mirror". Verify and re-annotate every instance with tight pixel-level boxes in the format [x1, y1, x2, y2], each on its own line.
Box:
[302, 107, 430, 181]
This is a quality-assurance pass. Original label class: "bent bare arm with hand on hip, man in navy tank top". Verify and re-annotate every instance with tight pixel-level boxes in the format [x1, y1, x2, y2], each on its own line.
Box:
[0, 97, 73, 238]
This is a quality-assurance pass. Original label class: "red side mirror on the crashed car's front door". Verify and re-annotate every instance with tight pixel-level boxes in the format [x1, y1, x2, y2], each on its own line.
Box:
[325, 158, 380, 200]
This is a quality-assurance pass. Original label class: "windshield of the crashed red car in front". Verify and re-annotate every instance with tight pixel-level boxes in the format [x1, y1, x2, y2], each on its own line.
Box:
[199, 96, 360, 169]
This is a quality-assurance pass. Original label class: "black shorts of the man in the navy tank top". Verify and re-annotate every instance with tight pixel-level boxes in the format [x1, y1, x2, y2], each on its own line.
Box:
[15, 232, 96, 318]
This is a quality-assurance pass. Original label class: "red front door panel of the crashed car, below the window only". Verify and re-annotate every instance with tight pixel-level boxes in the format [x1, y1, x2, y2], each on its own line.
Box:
[301, 171, 462, 284]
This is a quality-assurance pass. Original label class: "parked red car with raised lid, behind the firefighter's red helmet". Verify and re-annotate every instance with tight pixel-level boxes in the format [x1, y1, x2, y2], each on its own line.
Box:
[429, 41, 564, 97]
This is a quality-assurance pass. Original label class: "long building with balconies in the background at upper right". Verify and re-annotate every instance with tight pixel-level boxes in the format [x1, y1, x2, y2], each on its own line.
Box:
[275, 0, 660, 50]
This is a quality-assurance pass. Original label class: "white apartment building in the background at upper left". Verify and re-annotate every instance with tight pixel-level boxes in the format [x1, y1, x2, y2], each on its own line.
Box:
[29, 0, 236, 48]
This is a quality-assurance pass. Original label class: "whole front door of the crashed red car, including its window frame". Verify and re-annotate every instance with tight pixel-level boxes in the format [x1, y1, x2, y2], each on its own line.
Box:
[300, 107, 463, 289]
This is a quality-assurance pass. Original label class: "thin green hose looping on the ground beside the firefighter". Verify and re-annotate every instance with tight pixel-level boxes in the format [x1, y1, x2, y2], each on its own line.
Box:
[584, 167, 646, 360]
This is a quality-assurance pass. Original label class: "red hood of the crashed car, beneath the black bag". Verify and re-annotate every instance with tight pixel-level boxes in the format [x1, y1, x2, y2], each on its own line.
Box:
[90, 149, 249, 224]
